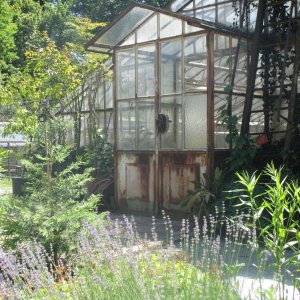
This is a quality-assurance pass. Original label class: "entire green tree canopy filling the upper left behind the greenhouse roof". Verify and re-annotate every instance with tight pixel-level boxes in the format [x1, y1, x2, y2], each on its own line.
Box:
[0, 0, 169, 135]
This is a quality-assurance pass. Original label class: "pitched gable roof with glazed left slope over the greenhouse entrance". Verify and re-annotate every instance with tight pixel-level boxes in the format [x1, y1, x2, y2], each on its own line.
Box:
[85, 3, 250, 54]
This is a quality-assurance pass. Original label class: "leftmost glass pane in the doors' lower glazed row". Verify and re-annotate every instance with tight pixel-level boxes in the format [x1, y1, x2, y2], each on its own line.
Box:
[117, 101, 136, 149]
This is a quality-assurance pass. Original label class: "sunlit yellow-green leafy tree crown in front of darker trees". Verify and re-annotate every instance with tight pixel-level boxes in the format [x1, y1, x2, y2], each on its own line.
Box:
[0, 35, 81, 137]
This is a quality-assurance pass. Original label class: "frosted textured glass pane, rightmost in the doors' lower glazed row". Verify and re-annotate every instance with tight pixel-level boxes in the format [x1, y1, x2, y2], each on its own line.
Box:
[184, 94, 207, 149]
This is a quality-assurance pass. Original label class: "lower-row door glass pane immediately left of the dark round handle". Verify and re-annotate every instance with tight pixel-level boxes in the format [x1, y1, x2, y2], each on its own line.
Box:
[138, 99, 155, 150]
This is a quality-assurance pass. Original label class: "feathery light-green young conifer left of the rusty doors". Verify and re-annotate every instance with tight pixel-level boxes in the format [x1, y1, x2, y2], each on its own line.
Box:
[0, 120, 104, 262]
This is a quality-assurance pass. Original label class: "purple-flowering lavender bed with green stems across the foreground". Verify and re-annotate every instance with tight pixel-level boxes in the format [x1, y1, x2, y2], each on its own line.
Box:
[0, 207, 296, 300]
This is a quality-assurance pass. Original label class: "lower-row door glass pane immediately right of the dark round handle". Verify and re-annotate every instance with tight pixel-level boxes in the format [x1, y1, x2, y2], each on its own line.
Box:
[160, 96, 183, 149]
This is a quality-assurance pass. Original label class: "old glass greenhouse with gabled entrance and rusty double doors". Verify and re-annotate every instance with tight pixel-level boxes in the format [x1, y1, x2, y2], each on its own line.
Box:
[86, 0, 300, 212]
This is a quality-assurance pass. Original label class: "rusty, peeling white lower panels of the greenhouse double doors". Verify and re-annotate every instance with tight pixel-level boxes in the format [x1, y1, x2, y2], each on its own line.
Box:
[116, 151, 207, 213]
